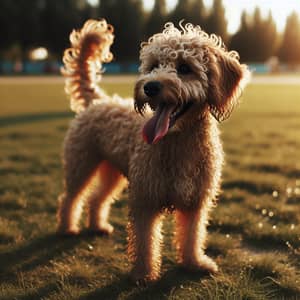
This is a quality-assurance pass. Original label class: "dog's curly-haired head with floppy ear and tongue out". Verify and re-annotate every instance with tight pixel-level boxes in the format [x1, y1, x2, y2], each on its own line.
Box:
[135, 23, 249, 144]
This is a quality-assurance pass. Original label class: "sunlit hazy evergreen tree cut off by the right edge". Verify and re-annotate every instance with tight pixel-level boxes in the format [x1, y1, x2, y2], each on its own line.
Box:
[279, 12, 300, 66]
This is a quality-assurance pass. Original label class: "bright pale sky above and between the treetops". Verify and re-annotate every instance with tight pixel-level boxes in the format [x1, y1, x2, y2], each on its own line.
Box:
[88, 0, 300, 33]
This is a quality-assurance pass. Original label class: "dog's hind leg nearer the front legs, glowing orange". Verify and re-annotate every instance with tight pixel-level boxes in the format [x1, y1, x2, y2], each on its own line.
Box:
[88, 161, 126, 234]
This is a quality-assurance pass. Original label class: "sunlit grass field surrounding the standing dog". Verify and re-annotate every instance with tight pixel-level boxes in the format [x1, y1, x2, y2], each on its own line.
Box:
[0, 78, 300, 300]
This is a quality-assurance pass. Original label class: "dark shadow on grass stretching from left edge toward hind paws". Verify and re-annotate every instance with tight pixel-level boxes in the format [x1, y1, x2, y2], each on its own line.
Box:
[0, 233, 89, 276]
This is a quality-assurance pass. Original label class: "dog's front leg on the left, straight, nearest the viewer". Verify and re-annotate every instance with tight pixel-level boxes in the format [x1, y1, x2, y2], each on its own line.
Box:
[128, 207, 162, 284]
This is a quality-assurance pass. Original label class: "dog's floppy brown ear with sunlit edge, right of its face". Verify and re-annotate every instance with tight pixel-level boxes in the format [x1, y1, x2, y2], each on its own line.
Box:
[207, 52, 250, 122]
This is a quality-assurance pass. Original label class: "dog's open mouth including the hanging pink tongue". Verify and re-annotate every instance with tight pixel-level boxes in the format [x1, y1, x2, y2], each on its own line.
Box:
[143, 101, 193, 144]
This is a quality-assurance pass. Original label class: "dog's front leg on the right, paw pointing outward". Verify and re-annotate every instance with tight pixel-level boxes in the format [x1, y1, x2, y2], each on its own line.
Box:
[175, 207, 218, 273]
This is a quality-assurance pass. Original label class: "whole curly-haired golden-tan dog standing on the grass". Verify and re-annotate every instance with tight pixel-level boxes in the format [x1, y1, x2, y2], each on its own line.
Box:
[58, 20, 249, 282]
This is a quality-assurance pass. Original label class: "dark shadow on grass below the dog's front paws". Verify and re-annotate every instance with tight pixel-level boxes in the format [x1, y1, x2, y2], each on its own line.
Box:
[80, 266, 208, 300]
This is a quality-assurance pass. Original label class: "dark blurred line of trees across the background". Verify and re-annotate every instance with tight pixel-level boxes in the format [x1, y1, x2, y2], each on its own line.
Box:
[0, 0, 300, 65]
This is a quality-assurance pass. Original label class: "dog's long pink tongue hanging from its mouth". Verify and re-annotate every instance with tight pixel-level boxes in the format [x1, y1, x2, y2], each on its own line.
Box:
[143, 104, 175, 144]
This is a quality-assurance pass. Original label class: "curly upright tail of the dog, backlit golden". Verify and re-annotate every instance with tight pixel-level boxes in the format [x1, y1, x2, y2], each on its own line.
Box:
[61, 19, 114, 113]
